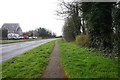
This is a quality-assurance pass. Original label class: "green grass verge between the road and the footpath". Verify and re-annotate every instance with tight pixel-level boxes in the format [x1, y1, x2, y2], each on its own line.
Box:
[2, 41, 55, 78]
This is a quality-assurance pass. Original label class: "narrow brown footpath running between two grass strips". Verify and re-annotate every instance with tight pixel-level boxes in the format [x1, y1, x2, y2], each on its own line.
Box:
[42, 43, 66, 78]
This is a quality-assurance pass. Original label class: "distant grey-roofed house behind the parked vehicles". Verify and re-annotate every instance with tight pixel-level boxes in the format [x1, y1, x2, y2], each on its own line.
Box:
[2, 23, 22, 35]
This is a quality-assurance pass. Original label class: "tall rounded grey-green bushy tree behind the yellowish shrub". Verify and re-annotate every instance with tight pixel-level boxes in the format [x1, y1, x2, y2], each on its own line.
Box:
[63, 3, 81, 41]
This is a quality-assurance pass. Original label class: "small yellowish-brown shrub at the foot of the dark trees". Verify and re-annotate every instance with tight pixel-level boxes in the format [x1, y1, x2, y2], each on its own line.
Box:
[75, 35, 89, 47]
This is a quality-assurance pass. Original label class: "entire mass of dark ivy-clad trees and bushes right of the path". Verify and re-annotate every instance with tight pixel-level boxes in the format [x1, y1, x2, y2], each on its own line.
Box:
[58, 1, 120, 56]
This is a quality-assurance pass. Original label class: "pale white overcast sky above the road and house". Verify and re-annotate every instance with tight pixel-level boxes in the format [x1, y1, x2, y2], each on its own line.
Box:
[0, 0, 64, 35]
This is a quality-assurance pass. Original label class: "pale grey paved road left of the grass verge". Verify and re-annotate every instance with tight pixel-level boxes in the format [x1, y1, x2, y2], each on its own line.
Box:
[0, 38, 56, 63]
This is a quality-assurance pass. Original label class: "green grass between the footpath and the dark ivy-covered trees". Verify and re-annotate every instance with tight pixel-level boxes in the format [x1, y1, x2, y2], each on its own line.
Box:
[58, 40, 118, 78]
